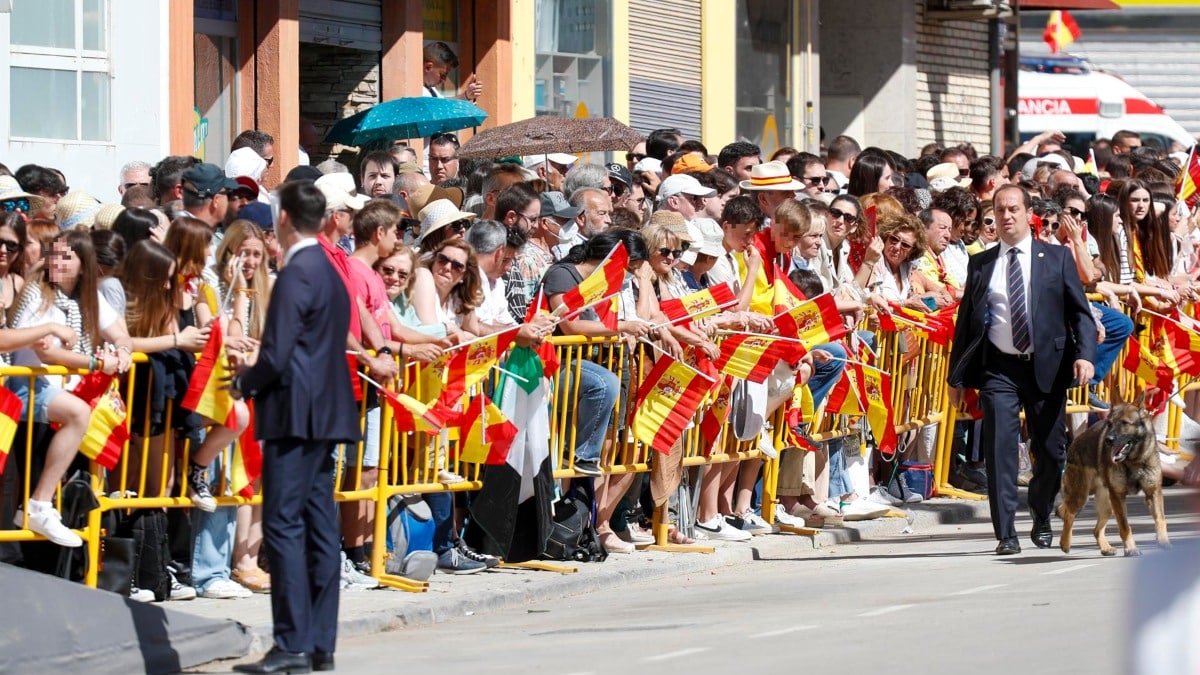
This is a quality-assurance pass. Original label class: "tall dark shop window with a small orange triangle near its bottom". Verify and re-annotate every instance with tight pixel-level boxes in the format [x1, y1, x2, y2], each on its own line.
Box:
[736, 0, 796, 153]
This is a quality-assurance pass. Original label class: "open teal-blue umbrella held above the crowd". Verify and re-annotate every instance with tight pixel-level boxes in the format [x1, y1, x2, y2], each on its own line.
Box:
[325, 96, 487, 147]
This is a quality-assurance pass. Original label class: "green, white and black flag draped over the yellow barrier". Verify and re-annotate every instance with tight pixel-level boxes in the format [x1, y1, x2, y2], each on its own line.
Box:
[470, 347, 554, 562]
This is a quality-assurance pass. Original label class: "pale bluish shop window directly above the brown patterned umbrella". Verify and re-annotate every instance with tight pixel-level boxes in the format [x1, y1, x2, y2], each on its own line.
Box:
[534, 0, 612, 118]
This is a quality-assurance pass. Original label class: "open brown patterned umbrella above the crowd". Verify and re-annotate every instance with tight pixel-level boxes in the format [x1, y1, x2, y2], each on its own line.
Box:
[458, 115, 644, 159]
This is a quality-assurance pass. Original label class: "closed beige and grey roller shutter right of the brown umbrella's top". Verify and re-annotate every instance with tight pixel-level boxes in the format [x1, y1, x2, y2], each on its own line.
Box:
[629, 0, 701, 138]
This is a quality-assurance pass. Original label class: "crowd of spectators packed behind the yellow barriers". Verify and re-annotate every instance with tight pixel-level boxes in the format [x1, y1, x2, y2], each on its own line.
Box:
[0, 115, 1200, 599]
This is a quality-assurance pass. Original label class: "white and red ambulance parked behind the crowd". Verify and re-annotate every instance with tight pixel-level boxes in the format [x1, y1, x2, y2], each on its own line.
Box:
[1018, 56, 1194, 156]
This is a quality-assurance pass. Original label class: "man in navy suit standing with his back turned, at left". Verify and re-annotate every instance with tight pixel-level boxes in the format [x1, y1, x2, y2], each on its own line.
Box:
[232, 181, 359, 673]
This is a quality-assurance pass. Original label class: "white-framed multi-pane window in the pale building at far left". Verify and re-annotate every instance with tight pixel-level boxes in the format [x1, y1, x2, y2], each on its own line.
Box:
[8, 0, 112, 142]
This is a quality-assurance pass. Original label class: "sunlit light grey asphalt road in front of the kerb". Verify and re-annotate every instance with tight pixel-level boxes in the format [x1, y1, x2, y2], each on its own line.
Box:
[211, 494, 1196, 675]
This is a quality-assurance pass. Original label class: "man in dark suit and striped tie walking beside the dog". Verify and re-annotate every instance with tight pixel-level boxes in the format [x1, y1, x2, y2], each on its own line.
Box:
[947, 185, 1096, 555]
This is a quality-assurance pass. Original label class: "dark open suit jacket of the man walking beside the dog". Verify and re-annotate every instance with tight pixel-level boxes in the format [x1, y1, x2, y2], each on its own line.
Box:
[947, 239, 1096, 394]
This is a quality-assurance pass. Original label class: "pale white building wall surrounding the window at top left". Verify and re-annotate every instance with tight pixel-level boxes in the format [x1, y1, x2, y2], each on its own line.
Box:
[0, 0, 169, 202]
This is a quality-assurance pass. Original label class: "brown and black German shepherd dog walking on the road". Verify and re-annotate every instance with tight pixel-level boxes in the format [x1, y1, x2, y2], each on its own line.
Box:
[1057, 396, 1170, 556]
